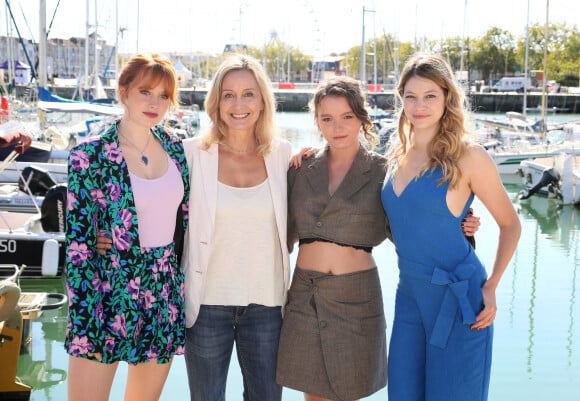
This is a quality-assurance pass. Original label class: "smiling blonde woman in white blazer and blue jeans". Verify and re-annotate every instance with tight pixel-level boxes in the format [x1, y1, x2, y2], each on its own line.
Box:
[182, 55, 291, 401]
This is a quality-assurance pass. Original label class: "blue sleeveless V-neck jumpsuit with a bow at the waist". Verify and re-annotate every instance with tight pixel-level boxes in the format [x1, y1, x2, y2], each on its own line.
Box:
[381, 167, 493, 401]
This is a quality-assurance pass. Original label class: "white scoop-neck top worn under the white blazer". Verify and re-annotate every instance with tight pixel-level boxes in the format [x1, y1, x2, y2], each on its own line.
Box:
[202, 179, 284, 306]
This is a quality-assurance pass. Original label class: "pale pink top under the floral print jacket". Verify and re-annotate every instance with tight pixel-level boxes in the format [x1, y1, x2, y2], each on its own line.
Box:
[129, 155, 184, 248]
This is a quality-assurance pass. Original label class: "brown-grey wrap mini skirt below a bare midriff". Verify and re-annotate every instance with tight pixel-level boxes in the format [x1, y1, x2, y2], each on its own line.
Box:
[276, 267, 387, 401]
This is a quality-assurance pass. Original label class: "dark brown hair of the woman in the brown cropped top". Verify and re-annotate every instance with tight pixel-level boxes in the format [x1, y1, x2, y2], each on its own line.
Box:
[309, 76, 379, 147]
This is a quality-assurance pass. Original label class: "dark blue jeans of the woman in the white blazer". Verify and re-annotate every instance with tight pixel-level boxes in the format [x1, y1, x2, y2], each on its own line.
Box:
[185, 304, 282, 401]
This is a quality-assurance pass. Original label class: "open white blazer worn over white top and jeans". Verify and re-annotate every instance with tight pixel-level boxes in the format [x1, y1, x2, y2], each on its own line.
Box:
[182, 138, 292, 327]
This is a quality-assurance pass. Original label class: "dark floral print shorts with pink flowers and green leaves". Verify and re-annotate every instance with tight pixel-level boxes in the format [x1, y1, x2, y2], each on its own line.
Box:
[65, 243, 185, 364]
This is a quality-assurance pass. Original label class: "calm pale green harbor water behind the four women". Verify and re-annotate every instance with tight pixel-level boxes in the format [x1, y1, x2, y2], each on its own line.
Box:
[13, 113, 580, 401]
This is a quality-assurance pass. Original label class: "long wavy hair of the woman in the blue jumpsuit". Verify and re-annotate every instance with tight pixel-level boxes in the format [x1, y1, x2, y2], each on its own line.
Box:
[386, 54, 469, 189]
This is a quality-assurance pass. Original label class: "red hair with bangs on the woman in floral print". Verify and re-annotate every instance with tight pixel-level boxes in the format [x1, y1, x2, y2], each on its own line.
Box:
[117, 53, 178, 106]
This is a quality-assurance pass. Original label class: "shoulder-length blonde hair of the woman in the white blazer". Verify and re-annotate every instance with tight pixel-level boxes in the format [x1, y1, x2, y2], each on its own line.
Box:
[202, 54, 279, 156]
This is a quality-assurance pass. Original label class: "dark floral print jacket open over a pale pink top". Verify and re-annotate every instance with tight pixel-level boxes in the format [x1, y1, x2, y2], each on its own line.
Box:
[66, 123, 189, 348]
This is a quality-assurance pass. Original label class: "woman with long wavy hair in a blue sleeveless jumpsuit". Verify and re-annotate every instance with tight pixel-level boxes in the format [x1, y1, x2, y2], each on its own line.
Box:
[381, 55, 520, 401]
